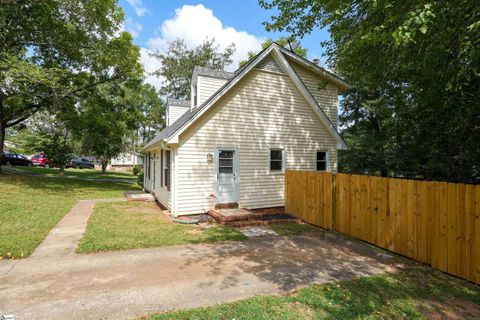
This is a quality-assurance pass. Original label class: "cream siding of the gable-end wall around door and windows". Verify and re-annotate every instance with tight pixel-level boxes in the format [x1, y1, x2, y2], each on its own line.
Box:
[176, 69, 337, 214]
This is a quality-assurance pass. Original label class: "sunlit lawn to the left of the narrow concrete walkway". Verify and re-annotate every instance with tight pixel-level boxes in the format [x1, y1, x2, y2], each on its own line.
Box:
[0, 175, 139, 258]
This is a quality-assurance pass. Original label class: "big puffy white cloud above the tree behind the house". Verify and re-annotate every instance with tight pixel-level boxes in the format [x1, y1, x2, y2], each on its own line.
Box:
[142, 4, 265, 88]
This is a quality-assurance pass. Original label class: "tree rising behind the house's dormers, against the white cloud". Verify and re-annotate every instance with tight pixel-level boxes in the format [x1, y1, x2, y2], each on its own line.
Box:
[152, 39, 235, 99]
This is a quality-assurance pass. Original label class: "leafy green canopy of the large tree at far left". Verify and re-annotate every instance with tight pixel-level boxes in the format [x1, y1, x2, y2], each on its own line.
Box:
[0, 0, 141, 170]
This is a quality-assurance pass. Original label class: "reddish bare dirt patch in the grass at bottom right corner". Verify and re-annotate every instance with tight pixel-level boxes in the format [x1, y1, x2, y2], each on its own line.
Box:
[418, 298, 480, 320]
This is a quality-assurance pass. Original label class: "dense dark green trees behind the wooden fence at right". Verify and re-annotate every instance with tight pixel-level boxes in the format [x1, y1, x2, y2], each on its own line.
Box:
[260, 0, 480, 182]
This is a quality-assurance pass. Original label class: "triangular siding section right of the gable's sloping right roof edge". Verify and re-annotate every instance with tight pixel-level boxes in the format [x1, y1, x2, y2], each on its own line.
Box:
[290, 61, 338, 127]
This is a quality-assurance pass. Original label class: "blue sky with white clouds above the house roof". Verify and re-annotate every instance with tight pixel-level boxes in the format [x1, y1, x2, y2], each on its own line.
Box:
[119, 0, 329, 88]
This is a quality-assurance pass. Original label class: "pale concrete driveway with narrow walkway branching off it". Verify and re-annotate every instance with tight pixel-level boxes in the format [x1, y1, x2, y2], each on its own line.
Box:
[0, 200, 404, 320]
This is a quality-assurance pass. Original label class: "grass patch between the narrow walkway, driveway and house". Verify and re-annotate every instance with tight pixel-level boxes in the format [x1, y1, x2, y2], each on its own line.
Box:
[78, 202, 246, 253]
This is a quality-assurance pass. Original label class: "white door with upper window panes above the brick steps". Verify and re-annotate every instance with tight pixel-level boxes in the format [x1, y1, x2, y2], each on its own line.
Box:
[216, 149, 238, 203]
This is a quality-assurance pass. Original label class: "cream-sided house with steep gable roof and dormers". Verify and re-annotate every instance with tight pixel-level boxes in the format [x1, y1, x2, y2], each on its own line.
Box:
[143, 43, 350, 216]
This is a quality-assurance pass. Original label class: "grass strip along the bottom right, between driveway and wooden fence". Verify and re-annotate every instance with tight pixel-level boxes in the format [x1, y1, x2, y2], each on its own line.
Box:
[144, 267, 480, 320]
